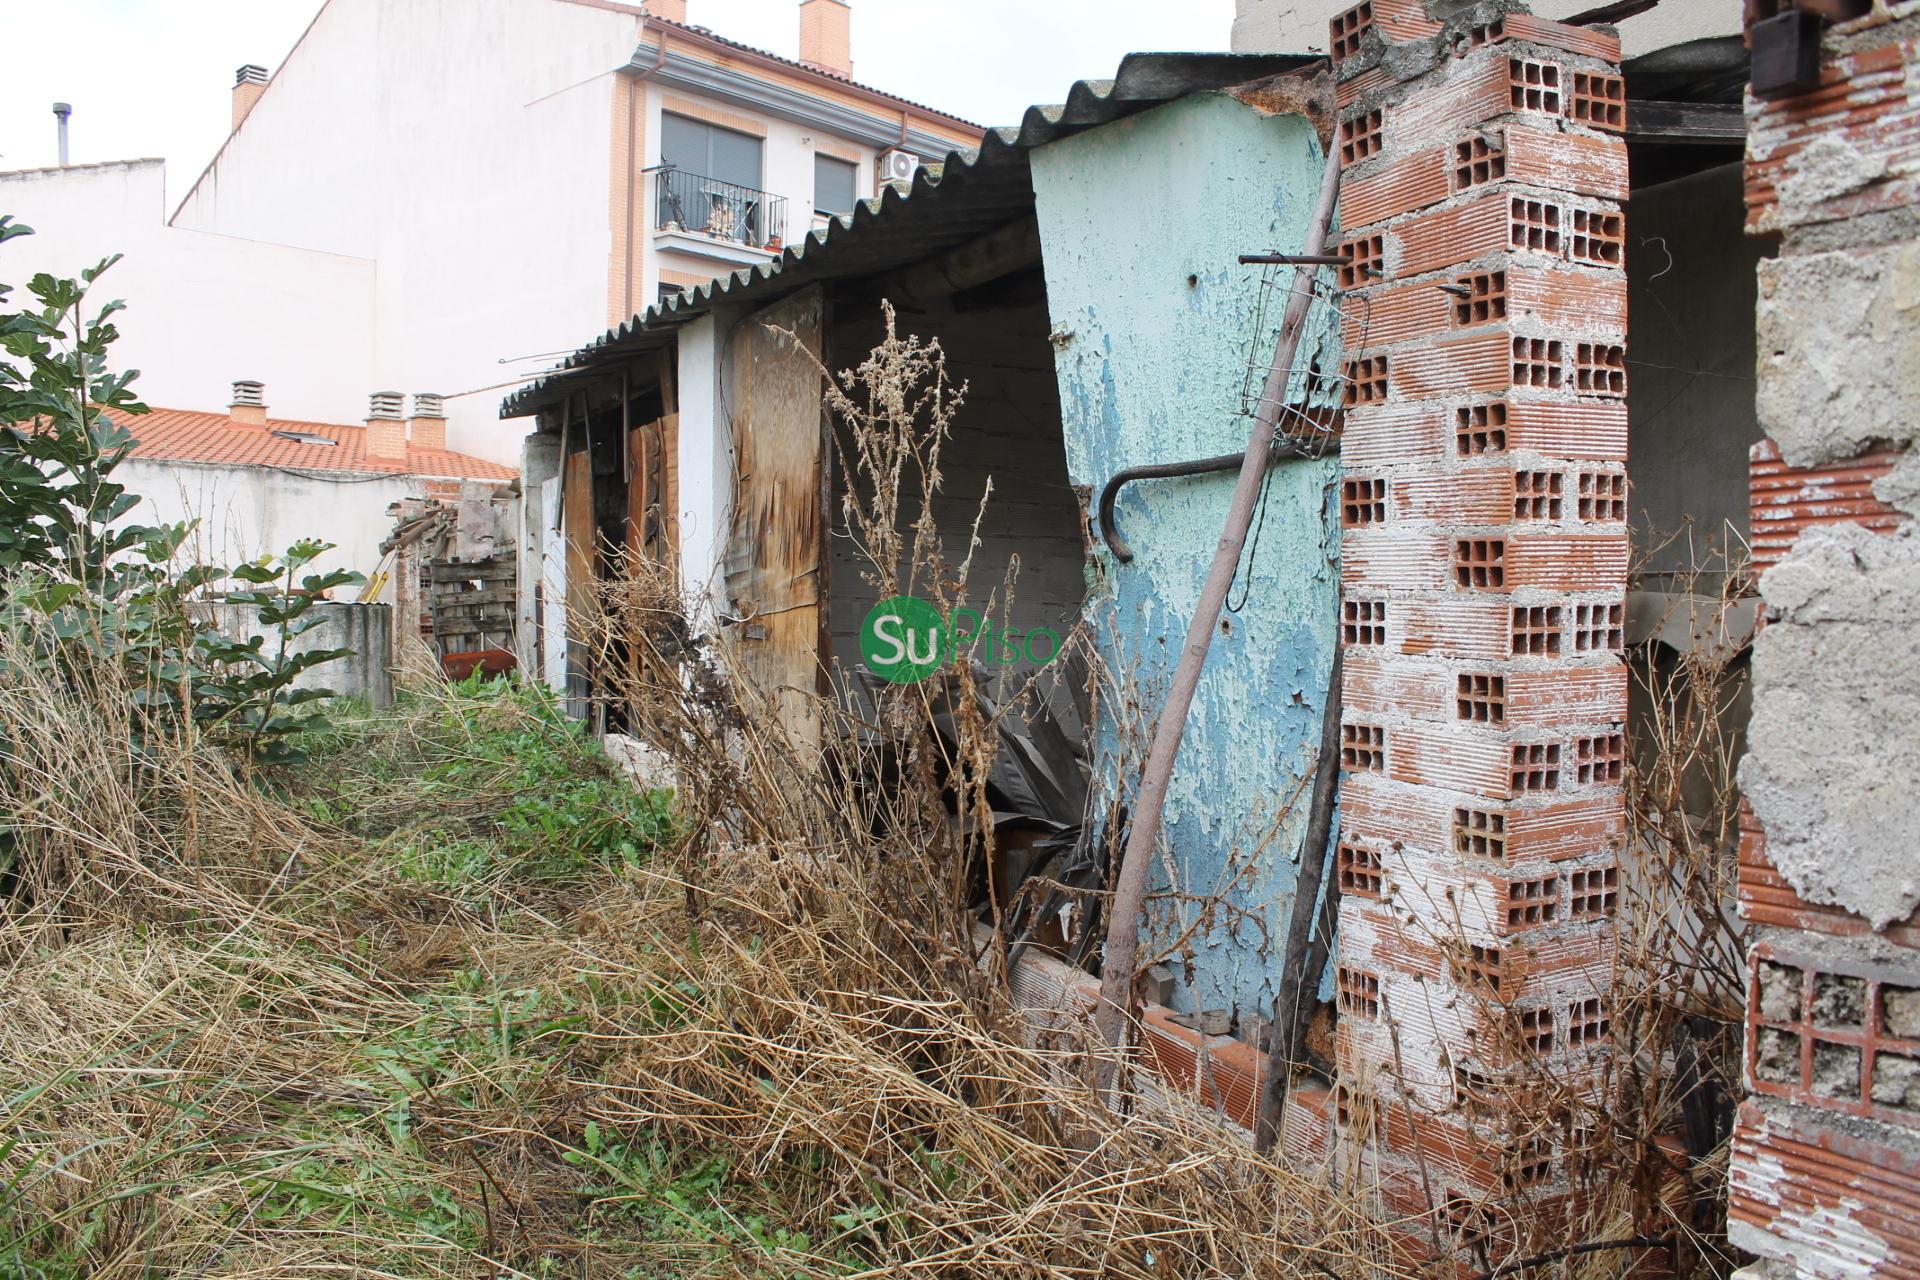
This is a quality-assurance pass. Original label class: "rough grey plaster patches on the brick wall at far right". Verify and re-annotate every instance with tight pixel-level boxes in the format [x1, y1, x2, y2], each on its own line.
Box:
[1741, 55, 1920, 927]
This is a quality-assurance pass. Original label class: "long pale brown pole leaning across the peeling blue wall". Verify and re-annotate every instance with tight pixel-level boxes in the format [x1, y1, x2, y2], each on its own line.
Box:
[1094, 142, 1340, 1074]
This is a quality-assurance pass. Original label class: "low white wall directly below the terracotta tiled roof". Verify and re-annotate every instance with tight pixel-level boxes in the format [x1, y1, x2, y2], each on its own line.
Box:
[115, 459, 415, 599]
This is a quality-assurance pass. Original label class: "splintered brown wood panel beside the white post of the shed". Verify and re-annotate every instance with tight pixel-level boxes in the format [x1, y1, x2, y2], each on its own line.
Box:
[726, 288, 826, 747]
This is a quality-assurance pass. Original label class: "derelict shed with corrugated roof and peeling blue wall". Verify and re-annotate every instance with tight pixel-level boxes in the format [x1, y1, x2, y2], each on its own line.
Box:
[505, 56, 1338, 1034]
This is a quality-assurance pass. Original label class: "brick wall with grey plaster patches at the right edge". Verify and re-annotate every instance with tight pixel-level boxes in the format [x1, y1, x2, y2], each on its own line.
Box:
[1728, 0, 1920, 1280]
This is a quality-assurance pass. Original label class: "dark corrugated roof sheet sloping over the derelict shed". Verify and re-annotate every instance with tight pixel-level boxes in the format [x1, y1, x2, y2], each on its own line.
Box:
[501, 54, 1325, 418]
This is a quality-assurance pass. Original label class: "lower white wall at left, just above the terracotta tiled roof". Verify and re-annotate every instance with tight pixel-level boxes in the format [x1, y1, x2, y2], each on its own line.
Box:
[0, 159, 376, 422]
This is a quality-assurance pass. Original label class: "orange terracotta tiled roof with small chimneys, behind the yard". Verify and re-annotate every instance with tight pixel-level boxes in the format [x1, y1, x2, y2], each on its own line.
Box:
[113, 409, 520, 480]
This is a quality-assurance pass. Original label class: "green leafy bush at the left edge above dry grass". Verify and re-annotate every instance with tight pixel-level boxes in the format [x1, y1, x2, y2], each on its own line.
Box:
[0, 215, 361, 764]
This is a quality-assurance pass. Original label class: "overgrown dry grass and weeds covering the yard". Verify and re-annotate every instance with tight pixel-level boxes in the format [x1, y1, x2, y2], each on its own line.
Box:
[0, 312, 1758, 1280]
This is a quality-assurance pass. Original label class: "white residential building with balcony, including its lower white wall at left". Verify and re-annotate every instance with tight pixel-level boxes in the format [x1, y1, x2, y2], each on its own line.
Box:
[0, 0, 979, 462]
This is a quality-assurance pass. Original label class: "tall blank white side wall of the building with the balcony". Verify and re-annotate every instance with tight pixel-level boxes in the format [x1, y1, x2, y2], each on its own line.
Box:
[175, 0, 637, 464]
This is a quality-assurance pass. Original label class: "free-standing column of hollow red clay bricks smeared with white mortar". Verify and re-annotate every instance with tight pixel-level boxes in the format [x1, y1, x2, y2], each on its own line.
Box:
[1332, 0, 1626, 1263]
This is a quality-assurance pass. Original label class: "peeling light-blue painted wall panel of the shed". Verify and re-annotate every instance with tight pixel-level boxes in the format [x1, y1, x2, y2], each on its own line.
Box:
[1033, 94, 1338, 1023]
